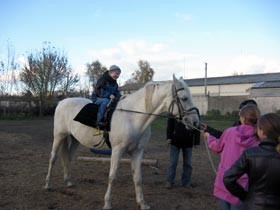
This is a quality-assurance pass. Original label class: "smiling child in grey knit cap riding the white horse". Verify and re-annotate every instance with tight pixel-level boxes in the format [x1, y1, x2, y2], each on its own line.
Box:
[92, 65, 121, 126]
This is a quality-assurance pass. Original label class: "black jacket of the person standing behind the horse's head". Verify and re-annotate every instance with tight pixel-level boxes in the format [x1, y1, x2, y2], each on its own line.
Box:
[166, 118, 200, 148]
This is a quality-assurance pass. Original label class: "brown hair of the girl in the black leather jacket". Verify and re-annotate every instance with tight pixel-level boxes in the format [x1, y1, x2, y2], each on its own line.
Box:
[258, 113, 280, 153]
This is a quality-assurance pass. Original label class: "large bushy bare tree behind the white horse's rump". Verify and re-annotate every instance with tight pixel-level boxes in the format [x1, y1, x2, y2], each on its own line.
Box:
[20, 42, 79, 115]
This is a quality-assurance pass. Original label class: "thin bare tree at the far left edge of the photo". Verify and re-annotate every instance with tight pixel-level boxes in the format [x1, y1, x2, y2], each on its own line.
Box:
[0, 41, 18, 96]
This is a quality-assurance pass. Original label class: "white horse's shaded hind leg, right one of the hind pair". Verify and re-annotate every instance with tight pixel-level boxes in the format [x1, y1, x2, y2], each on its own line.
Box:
[61, 136, 79, 187]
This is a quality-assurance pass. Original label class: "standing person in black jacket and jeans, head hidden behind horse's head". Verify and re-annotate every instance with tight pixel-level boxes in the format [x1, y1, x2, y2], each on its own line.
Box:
[166, 116, 200, 188]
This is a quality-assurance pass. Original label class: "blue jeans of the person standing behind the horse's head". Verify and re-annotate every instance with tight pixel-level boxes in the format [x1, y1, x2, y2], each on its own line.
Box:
[167, 144, 192, 186]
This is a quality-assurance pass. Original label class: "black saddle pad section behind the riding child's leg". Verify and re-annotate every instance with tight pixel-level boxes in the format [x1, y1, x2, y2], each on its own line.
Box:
[74, 103, 98, 127]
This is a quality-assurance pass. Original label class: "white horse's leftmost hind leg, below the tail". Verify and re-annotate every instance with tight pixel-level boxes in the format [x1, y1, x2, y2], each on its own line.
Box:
[45, 136, 67, 189]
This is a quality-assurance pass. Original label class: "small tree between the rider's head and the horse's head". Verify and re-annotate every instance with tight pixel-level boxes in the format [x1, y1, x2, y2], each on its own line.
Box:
[130, 60, 155, 84]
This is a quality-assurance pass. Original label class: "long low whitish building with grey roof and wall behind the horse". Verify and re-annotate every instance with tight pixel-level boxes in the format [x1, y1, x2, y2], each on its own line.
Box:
[120, 73, 280, 114]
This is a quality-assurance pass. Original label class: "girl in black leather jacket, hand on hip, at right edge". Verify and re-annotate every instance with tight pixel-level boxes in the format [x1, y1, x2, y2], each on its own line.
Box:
[223, 113, 280, 210]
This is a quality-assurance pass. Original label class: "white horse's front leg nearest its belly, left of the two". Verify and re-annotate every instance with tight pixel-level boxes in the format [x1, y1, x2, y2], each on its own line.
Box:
[103, 146, 124, 210]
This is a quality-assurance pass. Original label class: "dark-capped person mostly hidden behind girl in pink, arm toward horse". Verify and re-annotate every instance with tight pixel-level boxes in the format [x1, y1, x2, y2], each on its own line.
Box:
[200, 99, 258, 139]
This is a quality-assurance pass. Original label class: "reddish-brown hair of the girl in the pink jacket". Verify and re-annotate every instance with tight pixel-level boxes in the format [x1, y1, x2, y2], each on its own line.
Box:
[239, 104, 261, 126]
